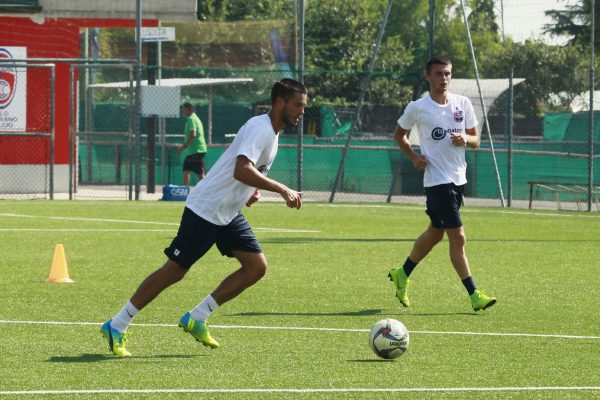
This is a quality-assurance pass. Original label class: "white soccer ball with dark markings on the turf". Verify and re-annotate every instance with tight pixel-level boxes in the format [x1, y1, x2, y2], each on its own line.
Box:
[369, 318, 409, 360]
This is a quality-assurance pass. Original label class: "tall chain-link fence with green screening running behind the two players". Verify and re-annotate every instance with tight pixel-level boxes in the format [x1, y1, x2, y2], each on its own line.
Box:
[2, 0, 600, 209]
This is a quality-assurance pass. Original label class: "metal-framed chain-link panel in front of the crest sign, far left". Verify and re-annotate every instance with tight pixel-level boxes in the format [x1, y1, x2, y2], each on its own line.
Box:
[0, 62, 54, 199]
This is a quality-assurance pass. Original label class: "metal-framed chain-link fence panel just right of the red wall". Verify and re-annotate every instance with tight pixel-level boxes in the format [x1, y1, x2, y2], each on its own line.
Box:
[69, 64, 134, 200]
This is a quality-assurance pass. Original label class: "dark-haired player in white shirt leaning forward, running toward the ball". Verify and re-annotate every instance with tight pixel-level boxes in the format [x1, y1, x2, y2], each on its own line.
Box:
[101, 78, 307, 357]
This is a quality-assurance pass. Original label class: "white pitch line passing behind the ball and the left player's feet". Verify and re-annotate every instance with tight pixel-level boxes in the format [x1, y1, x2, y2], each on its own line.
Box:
[0, 320, 600, 340]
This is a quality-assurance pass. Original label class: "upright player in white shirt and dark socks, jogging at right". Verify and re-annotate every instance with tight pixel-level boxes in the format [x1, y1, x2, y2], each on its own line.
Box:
[388, 56, 496, 311]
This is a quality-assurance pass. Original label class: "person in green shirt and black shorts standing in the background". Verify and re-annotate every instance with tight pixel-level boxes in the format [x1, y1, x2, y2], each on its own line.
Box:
[178, 102, 207, 186]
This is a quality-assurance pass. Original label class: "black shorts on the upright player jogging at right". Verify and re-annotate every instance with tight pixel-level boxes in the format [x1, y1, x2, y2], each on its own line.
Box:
[425, 183, 464, 229]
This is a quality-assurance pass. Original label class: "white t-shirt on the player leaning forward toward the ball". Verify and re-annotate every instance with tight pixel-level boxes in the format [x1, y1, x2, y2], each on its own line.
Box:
[185, 114, 279, 226]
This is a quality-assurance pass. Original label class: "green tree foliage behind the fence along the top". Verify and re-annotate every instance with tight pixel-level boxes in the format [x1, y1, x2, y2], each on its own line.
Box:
[94, 0, 600, 116]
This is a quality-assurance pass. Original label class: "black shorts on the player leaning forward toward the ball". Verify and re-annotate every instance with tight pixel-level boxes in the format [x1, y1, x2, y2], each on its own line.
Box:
[165, 207, 262, 268]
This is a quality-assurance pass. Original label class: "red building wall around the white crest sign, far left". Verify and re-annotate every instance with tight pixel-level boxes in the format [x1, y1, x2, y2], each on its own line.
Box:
[0, 17, 158, 191]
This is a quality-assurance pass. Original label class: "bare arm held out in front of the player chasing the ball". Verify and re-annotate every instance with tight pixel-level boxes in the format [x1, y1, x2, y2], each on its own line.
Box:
[233, 156, 302, 208]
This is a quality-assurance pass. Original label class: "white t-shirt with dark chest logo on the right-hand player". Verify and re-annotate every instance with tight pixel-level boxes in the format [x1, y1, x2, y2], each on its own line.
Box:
[398, 93, 478, 187]
